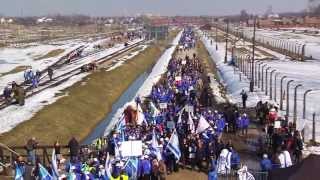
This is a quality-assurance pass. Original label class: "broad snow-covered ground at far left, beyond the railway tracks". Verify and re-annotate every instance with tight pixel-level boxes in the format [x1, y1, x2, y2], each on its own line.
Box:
[0, 38, 124, 90]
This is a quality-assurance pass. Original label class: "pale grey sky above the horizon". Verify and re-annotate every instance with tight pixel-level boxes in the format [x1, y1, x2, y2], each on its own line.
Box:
[0, 0, 308, 16]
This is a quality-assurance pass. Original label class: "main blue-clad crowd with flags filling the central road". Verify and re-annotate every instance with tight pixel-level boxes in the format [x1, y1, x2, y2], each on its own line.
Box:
[11, 30, 248, 180]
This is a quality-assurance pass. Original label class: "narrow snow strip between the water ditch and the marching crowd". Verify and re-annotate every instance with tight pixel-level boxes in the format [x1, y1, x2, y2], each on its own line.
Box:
[104, 32, 182, 135]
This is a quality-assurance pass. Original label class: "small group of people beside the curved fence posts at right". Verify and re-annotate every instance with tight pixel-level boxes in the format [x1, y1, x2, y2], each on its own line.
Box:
[256, 101, 303, 171]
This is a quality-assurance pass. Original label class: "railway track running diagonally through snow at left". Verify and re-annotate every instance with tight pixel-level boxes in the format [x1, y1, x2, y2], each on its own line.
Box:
[0, 40, 146, 110]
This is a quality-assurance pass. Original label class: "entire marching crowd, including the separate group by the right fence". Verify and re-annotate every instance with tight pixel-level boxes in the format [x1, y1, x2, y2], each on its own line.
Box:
[16, 30, 302, 180]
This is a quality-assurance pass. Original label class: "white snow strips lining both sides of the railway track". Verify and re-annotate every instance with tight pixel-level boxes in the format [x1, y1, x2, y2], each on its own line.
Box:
[0, 39, 142, 133]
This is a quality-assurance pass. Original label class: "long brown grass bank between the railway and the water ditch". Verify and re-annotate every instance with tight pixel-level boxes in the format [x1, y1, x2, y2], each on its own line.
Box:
[0, 32, 177, 146]
